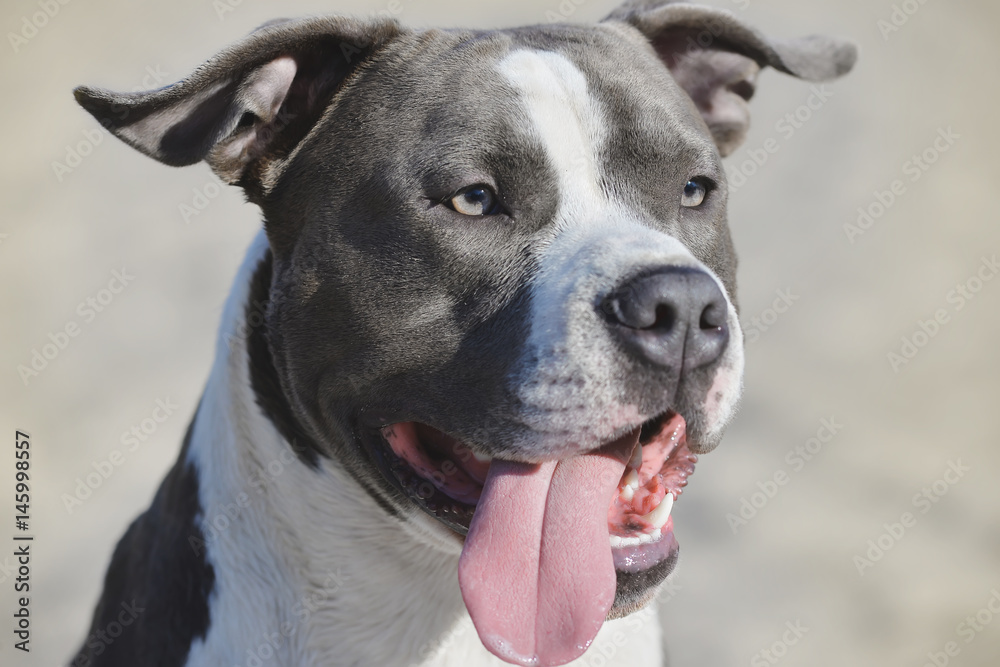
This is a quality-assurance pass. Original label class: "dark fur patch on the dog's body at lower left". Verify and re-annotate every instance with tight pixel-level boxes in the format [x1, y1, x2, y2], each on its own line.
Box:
[70, 420, 215, 667]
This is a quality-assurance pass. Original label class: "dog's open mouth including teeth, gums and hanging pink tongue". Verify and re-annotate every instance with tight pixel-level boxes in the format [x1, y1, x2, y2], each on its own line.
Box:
[381, 412, 697, 666]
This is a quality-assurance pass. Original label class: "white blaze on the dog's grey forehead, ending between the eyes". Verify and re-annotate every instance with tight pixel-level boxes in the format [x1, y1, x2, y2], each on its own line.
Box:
[498, 49, 606, 222]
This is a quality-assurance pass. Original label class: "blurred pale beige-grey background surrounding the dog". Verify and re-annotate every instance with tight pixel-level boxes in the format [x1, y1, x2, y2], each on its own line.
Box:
[0, 0, 1000, 667]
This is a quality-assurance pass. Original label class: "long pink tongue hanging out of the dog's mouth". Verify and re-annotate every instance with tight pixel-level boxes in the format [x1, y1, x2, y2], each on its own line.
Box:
[458, 429, 639, 667]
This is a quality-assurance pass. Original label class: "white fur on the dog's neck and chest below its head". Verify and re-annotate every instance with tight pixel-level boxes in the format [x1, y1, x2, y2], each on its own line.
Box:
[187, 233, 661, 667]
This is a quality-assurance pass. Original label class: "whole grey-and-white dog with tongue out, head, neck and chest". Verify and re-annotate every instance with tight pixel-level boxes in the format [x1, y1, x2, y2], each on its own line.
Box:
[72, 1, 856, 667]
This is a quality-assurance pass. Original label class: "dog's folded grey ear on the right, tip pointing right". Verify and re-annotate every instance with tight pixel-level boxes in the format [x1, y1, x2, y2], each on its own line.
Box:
[605, 0, 857, 156]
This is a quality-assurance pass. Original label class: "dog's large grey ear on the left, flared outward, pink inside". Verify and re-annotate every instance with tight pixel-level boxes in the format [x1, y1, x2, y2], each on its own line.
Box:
[74, 17, 400, 199]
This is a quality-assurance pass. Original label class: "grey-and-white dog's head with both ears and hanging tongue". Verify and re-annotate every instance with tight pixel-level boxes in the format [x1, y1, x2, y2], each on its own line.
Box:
[77, 2, 855, 665]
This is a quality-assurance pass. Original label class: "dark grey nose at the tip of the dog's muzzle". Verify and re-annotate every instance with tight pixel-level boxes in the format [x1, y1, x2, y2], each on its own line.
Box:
[600, 266, 729, 372]
